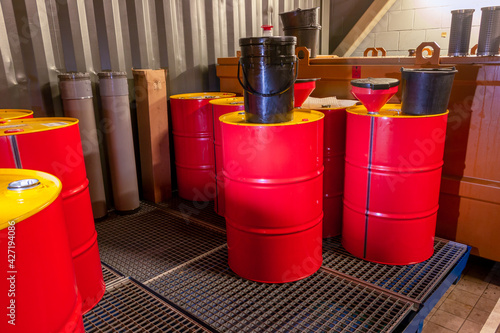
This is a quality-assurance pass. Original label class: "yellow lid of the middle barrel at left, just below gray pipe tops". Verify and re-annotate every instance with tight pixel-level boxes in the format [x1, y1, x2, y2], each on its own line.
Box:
[0, 117, 78, 136]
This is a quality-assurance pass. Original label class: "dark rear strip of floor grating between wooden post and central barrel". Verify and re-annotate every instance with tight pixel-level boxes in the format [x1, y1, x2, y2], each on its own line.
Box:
[157, 194, 226, 229]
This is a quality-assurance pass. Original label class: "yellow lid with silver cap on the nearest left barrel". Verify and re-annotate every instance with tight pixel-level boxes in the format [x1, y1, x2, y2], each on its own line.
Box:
[0, 169, 62, 230]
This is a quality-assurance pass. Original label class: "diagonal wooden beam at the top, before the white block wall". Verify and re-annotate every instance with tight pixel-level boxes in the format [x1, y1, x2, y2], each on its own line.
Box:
[333, 0, 396, 57]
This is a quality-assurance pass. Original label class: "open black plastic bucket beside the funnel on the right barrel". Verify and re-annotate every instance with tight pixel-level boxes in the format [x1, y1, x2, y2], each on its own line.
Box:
[401, 67, 457, 115]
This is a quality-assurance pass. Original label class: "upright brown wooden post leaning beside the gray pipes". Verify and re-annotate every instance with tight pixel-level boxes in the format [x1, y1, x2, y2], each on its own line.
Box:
[132, 69, 172, 203]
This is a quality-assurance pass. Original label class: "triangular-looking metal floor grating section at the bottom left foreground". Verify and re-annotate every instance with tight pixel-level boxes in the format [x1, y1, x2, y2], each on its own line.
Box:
[83, 278, 208, 333]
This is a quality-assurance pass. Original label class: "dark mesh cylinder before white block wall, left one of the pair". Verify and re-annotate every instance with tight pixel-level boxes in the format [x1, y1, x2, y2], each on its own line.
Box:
[448, 9, 474, 57]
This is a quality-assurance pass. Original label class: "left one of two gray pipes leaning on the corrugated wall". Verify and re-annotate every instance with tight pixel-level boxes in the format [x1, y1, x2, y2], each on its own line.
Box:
[59, 73, 107, 219]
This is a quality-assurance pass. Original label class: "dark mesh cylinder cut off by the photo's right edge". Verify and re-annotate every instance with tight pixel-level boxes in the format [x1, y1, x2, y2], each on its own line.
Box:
[477, 6, 500, 56]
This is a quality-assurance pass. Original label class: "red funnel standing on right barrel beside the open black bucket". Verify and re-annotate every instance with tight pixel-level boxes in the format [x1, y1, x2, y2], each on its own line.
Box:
[351, 77, 399, 113]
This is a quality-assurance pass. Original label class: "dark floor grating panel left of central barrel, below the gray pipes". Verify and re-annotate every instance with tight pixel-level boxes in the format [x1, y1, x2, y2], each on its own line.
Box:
[96, 203, 226, 282]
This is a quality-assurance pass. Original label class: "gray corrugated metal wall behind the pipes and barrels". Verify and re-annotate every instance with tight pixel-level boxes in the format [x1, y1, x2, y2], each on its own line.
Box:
[0, 0, 320, 116]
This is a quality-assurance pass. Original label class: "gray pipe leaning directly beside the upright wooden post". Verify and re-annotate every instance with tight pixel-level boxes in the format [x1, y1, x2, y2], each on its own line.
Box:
[99, 72, 139, 211]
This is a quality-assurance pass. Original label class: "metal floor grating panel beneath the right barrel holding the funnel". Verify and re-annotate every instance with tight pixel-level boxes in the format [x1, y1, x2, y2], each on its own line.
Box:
[323, 237, 467, 301]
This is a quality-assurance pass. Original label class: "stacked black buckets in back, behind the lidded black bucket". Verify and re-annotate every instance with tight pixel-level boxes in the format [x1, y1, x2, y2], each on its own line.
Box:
[280, 7, 321, 58]
